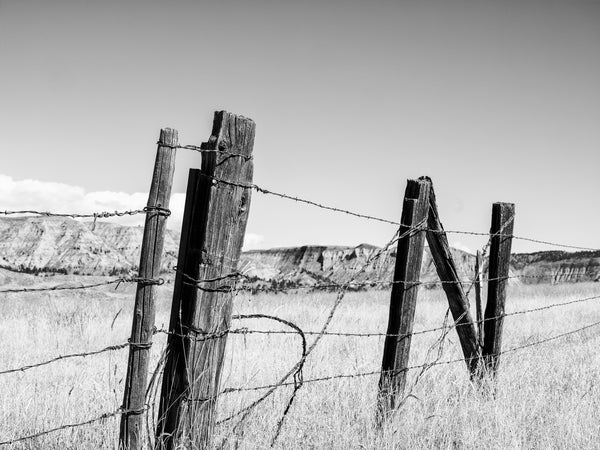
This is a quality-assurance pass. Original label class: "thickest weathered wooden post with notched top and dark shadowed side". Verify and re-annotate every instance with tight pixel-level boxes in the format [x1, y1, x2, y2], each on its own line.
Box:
[156, 111, 255, 450]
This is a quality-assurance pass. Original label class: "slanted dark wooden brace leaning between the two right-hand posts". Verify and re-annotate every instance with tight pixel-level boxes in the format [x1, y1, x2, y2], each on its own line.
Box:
[420, 177, 481, 377]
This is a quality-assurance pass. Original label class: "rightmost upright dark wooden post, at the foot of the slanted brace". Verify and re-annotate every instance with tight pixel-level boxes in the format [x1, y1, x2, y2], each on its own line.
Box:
[483, 203, 515, 376]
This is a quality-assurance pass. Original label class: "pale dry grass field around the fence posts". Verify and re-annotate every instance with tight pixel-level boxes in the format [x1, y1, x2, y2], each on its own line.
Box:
[0, 277, 600, 450]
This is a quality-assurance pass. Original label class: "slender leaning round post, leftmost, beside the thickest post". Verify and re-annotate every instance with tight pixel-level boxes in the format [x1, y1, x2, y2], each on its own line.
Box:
[119, 128, 178, 450]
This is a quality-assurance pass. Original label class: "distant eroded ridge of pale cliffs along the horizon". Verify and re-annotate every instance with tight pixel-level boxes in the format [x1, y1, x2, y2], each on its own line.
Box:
[0, 217, 600, 285]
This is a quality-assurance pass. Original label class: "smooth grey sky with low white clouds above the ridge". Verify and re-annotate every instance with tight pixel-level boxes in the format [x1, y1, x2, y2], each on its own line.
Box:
[0, 0, 600, 251]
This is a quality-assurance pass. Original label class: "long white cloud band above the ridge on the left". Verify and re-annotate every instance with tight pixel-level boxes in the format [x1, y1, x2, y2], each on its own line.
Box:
[0, 175, 185, 230]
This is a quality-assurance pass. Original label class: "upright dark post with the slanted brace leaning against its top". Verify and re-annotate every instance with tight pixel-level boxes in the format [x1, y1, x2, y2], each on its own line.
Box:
[377, 180, 431, 424]
